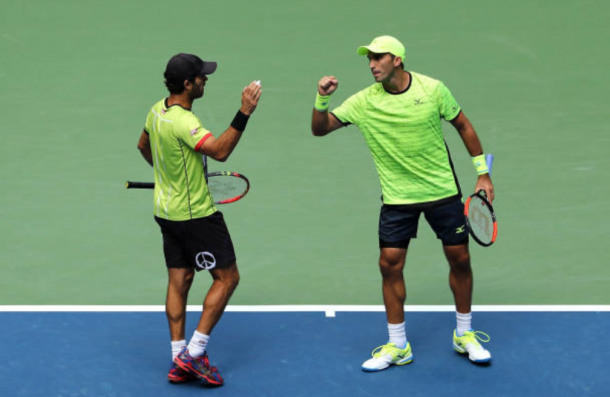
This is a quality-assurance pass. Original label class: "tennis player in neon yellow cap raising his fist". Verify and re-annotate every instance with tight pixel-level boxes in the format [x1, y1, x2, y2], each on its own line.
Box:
[311, 36, 494, 371]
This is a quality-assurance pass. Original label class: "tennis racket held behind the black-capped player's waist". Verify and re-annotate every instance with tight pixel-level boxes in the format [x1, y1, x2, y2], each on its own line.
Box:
[125, 171, 250, 204]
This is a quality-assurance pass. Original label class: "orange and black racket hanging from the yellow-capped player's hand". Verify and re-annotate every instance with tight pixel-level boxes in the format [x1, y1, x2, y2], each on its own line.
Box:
[464, 154, 498, 247]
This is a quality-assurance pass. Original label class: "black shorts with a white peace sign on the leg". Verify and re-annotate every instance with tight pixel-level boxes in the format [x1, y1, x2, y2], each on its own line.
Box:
[155, 211, 236, 271]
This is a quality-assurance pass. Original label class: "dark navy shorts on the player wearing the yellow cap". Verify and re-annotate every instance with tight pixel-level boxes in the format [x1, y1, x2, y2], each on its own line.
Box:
[379, 196, 468, 248]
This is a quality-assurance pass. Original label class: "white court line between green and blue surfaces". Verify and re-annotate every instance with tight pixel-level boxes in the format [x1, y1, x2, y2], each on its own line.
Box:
[0, 305, 610, 317]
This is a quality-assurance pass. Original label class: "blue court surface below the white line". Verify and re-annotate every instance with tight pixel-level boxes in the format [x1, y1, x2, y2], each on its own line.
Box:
[0, 312, 610, 397]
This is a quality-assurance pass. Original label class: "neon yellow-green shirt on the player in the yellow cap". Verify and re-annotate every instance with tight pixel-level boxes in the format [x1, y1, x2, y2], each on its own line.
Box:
[332, 72, 461, 204]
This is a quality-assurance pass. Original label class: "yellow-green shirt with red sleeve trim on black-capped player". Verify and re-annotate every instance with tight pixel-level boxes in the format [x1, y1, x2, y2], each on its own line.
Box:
[144, 99, 216, 221]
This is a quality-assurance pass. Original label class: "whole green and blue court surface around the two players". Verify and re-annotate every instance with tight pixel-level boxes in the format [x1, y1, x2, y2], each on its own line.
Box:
[0, 0, 610, 397]
